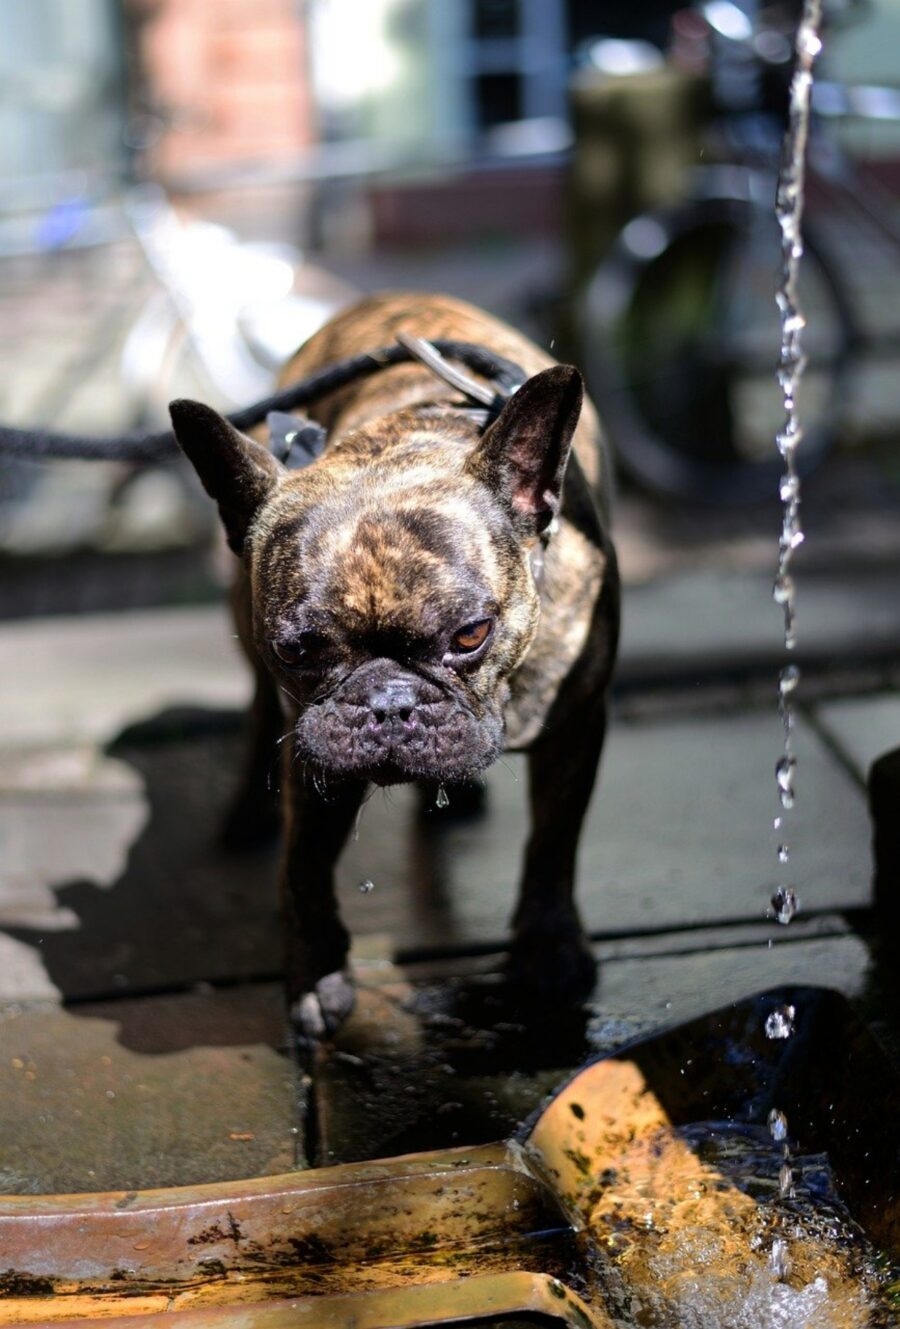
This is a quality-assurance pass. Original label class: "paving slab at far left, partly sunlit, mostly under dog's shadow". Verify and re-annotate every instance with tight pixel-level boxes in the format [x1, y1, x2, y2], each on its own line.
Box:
[0, 712, 281, 999]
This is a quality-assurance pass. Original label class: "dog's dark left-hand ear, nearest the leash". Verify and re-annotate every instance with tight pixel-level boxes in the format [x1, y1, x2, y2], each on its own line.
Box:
[169, 400, 284, 554]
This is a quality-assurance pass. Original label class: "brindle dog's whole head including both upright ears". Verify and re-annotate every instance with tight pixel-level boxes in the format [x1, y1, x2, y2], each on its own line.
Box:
[171, 365, 584, 784]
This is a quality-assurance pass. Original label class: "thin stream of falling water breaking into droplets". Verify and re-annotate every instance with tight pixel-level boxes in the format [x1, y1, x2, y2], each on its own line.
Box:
[766, 0, 822, 1281]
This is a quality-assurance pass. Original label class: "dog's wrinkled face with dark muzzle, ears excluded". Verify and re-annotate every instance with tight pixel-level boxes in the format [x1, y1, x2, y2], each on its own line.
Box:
[250, 468, 537, 784]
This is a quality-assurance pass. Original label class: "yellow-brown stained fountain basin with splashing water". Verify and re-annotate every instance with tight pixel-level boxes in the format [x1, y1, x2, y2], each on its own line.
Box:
[0, 987, 900, 1329]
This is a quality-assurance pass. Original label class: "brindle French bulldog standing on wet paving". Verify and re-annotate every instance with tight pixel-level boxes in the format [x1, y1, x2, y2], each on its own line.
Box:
[171, 295, 618, 1038]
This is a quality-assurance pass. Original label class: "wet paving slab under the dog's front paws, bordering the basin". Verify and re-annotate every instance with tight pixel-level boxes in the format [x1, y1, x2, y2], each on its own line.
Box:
[314, 922, 869, 1164]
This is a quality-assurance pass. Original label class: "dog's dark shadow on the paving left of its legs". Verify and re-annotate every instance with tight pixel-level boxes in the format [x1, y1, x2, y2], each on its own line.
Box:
[7, 707, 281, 1051]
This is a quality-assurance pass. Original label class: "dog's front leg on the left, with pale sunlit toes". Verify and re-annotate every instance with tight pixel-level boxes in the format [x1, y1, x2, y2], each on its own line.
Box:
[282, 769, 366, 1041]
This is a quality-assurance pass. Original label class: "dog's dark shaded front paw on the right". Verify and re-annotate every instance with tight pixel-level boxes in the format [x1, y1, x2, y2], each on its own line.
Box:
[506, 922, 597, 1006]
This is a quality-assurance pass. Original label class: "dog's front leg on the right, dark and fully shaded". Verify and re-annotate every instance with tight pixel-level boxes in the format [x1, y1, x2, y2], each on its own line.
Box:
[510, 694, 606, 1001]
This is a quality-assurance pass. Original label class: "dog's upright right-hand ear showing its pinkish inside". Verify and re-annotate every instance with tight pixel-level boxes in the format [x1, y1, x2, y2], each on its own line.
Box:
[468, 364, 585, 534]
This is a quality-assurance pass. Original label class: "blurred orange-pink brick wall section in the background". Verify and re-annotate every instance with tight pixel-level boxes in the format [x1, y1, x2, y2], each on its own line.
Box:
[133, 0, 314, 179]
